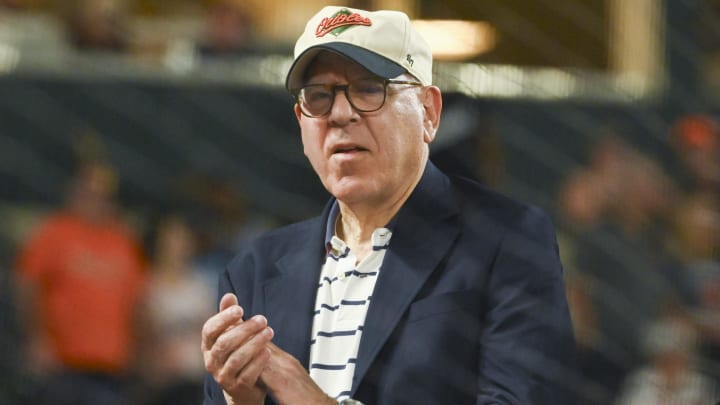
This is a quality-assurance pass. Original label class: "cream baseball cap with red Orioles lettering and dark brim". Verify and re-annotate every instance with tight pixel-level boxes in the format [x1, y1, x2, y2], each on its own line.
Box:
[285, 6, 432, 90]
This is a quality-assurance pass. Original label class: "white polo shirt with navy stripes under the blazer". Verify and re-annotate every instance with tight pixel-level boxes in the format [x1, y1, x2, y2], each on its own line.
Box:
[309, 203, 392, 400]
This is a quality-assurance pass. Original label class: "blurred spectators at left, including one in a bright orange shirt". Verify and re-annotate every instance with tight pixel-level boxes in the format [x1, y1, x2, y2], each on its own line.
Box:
[0, 152, 273, 405]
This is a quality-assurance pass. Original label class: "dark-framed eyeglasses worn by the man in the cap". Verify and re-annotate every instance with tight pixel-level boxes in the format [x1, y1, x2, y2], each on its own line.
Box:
[295, 79, 423, 118]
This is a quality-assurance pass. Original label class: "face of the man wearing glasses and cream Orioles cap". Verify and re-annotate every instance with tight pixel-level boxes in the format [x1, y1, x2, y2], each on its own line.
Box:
[295, 52, 439, 205]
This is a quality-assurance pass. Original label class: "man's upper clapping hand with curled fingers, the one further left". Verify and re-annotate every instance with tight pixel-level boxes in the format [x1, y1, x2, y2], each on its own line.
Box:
[201, 294, 273, 404]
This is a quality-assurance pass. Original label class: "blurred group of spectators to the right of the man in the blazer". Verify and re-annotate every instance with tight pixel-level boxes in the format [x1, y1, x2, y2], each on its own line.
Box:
[557, 115, 720, 404]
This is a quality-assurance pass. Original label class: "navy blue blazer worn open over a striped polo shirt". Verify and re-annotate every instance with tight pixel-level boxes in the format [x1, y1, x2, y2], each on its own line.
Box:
[204, 162, 574, 405]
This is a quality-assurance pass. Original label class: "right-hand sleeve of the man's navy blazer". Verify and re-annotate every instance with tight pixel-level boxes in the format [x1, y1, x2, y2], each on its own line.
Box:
[477, 207, 575, 405]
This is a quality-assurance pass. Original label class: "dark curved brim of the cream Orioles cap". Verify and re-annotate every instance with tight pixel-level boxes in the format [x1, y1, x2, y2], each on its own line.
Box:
[285, 42, 407, 91]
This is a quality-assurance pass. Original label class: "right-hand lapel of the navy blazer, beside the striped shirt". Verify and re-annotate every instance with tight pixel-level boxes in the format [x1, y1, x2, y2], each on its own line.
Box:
[352, 162, 459, 394]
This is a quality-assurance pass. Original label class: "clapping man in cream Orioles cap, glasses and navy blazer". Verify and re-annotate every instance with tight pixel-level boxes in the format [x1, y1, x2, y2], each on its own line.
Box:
[202, 7, 574, 405]
